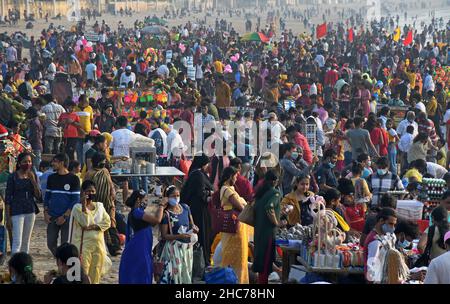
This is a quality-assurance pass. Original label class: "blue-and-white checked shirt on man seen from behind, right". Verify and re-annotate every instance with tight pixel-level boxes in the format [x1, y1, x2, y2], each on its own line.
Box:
[368, 172, 404, 207]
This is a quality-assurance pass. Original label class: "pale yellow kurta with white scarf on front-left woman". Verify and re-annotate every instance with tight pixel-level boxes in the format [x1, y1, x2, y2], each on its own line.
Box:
[70, 203, 111, 284]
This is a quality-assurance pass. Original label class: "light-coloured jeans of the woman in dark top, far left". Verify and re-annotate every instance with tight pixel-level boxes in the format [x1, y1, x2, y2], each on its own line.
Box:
[11, 213, 36, 254]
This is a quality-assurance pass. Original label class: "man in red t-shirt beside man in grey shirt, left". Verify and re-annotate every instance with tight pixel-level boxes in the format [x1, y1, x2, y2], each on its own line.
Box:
[58, 99, 83, 160]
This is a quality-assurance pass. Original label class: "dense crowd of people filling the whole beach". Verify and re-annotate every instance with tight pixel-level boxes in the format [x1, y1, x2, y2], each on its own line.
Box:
[0, 4, 450, 284]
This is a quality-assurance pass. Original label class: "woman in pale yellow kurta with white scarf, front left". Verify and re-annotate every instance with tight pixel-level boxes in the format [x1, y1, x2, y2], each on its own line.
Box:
[69, 180, 111, 284]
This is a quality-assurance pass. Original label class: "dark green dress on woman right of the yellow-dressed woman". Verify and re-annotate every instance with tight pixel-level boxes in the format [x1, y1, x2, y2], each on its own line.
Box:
[253, 188, 281, 273]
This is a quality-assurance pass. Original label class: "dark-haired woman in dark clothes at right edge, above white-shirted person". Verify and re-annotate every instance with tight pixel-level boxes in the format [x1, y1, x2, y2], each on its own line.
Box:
[417, 206, 449, 265]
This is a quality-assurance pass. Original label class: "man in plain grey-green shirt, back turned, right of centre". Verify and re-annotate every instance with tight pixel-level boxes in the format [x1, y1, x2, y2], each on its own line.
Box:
[346, 117, 379, 160]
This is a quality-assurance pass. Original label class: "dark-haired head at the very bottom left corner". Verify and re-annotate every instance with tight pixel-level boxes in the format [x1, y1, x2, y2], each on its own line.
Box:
[8, 252, 40, 284]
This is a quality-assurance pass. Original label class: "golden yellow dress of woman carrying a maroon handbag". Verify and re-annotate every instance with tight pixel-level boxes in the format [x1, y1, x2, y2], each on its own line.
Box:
[220, 186, 249, 284]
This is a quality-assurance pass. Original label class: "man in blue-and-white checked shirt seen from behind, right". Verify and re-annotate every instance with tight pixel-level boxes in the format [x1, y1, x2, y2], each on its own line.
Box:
[367, 157, 404, 208]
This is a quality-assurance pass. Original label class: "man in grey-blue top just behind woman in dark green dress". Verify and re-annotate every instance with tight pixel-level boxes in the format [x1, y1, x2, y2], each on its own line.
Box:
[280, 143, 310, 195]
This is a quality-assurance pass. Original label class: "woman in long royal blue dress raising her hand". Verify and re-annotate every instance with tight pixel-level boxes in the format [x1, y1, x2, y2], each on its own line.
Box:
[119, 190, 167, 284]
